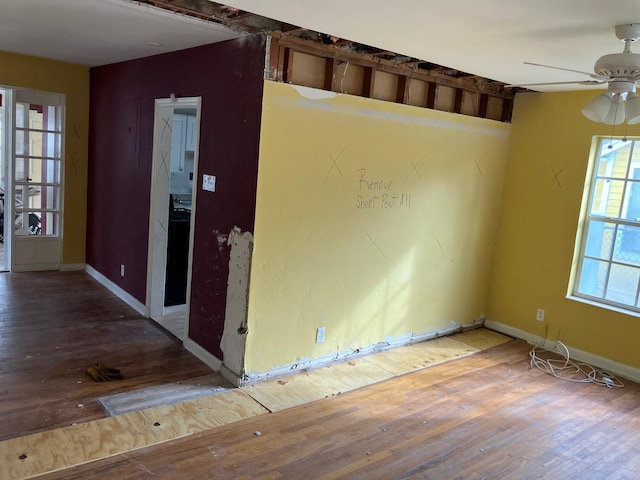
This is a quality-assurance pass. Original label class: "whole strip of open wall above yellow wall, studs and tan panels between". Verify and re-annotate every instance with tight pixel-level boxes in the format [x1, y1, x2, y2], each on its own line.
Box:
[265, 32, 515, 123]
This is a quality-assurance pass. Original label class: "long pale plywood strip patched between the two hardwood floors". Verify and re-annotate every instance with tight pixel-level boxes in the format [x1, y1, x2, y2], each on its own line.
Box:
[0, 329, 511, 480]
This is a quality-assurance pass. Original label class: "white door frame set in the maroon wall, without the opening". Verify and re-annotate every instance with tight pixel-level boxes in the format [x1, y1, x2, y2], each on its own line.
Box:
[145, 97, 202, 339]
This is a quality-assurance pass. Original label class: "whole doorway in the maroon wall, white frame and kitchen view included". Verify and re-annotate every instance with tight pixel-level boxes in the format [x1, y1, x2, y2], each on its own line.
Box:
[146, 97, 201, 342]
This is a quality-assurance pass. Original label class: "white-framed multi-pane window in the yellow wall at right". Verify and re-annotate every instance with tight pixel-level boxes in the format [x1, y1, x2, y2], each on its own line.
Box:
[573, 139, 640, 312]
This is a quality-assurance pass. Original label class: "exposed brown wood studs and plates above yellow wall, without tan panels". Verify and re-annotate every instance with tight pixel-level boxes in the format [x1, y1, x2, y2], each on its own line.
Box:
[268, 32, 514, 122]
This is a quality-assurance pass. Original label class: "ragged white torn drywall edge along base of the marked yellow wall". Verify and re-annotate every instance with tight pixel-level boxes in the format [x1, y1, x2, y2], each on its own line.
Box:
[238, 315, 484, 386]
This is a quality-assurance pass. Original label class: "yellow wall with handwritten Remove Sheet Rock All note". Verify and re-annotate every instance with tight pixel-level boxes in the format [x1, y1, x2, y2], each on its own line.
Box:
[245, 82, 511, 373]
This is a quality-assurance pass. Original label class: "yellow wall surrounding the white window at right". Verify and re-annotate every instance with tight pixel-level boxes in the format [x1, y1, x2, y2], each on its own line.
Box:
[487, 91, 640, 367]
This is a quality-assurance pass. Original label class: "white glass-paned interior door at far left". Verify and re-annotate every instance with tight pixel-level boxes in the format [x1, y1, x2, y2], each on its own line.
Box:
[10, 89, 64, 271]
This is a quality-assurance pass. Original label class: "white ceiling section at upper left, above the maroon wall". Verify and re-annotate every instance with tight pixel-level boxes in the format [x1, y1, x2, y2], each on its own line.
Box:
[0, 0, 238, 66]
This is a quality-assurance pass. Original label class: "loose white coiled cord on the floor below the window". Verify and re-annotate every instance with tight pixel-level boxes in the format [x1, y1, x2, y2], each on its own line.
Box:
[529, 342, 624, 388]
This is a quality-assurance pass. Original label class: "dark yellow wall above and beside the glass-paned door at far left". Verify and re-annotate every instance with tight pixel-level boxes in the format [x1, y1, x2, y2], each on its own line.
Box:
[0, 52, 89, 264]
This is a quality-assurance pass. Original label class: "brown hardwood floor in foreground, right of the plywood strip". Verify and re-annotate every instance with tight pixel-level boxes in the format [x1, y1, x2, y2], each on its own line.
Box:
[32, 340, 640, 480]
